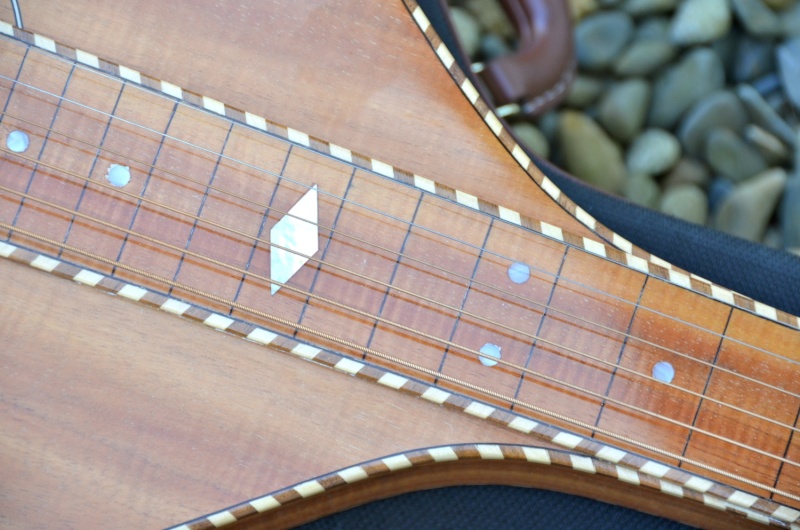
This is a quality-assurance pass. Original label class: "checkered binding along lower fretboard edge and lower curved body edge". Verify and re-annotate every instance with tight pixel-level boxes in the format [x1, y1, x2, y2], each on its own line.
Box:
[0, 242, 800, 530]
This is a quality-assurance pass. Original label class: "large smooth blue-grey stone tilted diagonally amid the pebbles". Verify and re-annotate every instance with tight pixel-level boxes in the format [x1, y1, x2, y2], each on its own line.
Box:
[648, 48, 725, 129]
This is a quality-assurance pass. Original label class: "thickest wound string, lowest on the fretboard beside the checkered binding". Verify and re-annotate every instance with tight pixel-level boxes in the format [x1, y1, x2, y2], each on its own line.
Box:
[0, 222, 800, 501]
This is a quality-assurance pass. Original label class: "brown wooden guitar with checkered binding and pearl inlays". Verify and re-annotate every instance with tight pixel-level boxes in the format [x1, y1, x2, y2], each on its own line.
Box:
[0, 0, 800, 528]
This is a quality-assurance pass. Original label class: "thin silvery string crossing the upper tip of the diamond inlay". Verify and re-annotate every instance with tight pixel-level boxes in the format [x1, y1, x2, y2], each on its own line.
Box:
[0, 75, 800, 376]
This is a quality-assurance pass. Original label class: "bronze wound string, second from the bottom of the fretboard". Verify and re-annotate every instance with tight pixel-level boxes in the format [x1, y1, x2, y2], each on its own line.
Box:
[0, 190, 800, 467]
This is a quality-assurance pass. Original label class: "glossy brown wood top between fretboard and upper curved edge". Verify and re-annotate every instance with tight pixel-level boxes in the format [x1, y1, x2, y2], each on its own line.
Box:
[15, 0, 589, 234]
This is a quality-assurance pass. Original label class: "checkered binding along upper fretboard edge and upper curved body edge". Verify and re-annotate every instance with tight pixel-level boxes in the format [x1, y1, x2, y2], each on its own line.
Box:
[0, 23, 800, 329]
